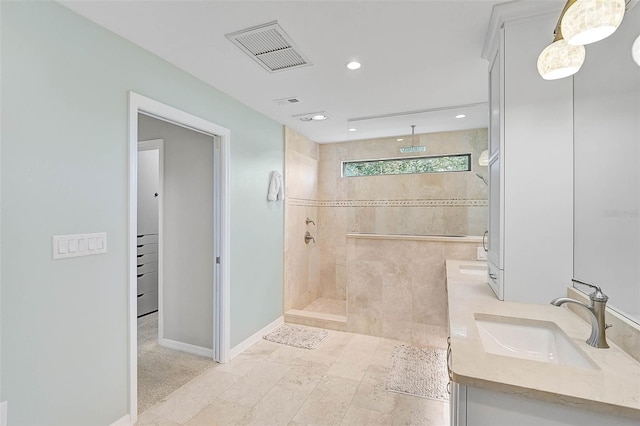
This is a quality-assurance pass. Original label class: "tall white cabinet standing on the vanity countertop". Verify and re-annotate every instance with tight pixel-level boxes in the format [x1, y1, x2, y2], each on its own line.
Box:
[483, 8, 573, 304]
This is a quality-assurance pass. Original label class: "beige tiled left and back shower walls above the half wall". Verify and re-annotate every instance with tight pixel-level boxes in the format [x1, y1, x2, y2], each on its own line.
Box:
[285, 128, 487, 322]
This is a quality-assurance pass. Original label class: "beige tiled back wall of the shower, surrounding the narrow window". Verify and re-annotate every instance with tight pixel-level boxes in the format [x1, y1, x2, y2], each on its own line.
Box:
[317, 129, 488, 302]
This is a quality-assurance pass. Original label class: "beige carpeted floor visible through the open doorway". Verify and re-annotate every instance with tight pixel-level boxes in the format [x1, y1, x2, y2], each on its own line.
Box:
[138, 312, 215, 413]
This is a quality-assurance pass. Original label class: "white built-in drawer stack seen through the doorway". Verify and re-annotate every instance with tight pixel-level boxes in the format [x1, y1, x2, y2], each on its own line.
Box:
[136, 234, 158, 316]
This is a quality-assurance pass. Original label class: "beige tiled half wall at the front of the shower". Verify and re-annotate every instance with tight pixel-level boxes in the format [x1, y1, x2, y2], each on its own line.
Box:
[347, 236, 478, 347]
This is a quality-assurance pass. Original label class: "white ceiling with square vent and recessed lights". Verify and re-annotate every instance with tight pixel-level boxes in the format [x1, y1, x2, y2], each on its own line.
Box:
[61, 0, 510, 143]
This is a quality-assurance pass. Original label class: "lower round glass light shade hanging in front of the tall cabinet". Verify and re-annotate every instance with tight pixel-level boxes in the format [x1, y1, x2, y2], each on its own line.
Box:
[538, 39, 585, 80]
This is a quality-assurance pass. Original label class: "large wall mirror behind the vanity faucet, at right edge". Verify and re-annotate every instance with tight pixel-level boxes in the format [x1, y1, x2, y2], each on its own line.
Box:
[576, 6, 640, 324]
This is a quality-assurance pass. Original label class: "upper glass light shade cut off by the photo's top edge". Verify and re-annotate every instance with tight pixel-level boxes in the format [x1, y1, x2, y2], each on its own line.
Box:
[560, 0, 625, 46]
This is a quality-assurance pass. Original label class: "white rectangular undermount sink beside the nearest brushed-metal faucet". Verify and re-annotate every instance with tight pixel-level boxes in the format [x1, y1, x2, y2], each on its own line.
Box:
[475, 314, 599, 370]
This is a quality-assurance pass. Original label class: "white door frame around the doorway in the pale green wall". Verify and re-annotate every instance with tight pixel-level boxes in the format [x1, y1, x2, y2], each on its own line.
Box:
[128, 92, 231, 424]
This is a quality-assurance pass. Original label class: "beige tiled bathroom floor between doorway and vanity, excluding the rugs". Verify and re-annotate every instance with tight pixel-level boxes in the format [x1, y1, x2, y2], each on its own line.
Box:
[138, 331, 449, 426]
